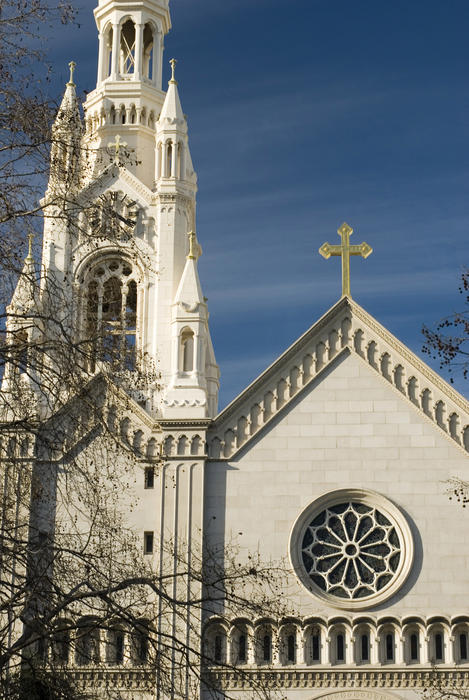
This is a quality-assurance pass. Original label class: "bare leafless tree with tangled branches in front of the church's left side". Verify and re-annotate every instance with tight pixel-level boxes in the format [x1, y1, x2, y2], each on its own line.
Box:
[0, 0, 292, 700]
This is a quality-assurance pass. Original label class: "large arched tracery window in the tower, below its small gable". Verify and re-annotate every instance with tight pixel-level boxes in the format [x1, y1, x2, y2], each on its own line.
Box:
[86, 259, 137, 371]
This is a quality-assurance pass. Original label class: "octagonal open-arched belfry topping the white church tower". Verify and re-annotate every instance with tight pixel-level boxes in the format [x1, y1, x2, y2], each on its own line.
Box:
[84, 0, 171, 188]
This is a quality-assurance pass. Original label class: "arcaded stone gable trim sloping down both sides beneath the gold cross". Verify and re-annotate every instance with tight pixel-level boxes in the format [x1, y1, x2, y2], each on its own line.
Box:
[208, 297, 469, 459]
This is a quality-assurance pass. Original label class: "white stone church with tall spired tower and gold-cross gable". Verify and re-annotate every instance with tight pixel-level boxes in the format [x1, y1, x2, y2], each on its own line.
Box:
[3, 0, 469, 700]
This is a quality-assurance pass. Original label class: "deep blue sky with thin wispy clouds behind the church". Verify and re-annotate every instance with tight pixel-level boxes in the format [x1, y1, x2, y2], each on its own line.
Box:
[50, 0, 469, 406]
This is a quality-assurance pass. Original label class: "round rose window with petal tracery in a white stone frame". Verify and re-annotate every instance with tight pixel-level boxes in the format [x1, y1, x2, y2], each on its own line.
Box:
[290, 490, 413, 609]
